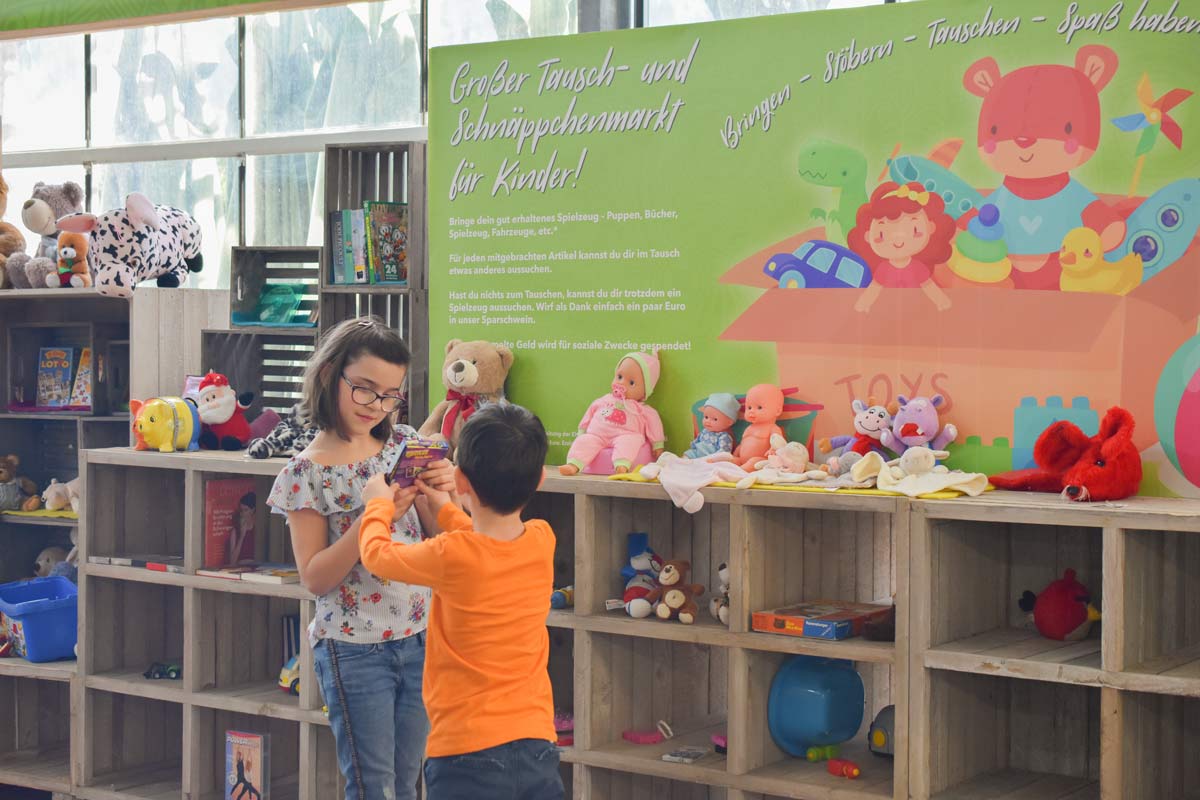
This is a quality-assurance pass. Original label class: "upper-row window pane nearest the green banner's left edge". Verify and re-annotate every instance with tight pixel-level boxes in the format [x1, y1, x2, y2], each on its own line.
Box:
[246, 0, 432, 134]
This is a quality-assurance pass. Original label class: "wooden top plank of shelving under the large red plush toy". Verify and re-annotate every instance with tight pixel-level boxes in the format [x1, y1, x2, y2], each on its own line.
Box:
[912, 492, 1200, 533]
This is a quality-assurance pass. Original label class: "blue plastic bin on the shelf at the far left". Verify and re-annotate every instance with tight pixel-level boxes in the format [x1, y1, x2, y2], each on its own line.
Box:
[0, 576, 79, 662]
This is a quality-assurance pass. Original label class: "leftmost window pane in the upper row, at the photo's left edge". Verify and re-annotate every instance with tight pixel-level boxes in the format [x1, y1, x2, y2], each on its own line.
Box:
[0, 36, 84, 152]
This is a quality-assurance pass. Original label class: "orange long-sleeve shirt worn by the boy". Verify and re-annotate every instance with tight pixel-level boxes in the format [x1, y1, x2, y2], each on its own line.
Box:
[359, 498, 558, 758]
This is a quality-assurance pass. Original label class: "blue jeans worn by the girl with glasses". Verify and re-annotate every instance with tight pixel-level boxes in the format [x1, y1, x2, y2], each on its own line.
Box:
[313, 632, 430, 800]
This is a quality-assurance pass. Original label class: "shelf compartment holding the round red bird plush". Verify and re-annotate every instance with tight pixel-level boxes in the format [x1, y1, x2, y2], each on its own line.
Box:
[914, 519, 1104, 686]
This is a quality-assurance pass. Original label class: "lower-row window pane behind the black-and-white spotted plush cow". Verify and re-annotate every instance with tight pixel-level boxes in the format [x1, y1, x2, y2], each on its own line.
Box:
[92, 158, 238, 289]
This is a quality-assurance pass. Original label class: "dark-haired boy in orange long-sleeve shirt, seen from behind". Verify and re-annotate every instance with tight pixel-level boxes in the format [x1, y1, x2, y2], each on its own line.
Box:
[359, 404, 563, 800]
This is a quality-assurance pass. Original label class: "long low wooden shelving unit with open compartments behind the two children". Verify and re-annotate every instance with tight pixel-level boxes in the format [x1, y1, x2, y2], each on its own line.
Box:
[0, 438, 1200, 800]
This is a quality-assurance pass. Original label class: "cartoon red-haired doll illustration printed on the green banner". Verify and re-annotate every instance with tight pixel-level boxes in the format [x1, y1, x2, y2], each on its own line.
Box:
[847, 181, 955, 312]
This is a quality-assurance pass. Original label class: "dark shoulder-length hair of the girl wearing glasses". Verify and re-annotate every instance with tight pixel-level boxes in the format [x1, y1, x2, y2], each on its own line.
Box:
[300, 317, 412, 441]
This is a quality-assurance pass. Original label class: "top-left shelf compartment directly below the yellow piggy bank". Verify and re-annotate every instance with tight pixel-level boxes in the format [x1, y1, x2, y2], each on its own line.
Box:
[85, 460, 185, 566]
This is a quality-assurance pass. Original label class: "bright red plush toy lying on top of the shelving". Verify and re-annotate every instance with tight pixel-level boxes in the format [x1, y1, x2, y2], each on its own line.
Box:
[991, 407, 1141, 501]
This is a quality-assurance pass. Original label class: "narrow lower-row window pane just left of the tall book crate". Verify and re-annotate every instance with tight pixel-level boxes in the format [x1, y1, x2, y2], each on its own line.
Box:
[246, 152, 325, 247]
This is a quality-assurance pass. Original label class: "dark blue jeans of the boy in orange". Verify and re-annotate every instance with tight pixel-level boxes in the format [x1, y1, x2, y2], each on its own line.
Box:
[425, 739, 563, 800]
